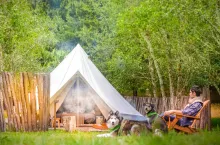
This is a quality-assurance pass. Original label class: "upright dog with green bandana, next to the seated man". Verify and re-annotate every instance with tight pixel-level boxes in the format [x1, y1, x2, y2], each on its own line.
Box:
[143, 103, 168, 136]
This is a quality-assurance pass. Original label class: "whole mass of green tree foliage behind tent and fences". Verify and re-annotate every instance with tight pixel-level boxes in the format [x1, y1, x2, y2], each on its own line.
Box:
[0, 0, 220, 96]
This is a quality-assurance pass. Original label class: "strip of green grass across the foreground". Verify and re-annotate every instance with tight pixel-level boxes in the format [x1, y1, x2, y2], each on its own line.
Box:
[0, 128, 220, 145]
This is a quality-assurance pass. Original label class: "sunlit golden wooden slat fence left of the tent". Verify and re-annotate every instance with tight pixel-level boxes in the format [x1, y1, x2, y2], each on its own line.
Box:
[0, 73, 50, 132]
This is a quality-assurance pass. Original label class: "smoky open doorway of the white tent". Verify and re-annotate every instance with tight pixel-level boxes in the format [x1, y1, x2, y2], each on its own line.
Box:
[56, 77, 104, 126]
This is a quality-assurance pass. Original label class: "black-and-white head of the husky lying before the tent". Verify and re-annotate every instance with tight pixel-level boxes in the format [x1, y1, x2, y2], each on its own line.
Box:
[107, 111, 123, 129]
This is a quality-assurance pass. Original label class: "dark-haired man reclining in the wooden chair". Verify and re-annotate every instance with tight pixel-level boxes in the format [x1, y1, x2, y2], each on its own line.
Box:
[160, 86, 203, 126]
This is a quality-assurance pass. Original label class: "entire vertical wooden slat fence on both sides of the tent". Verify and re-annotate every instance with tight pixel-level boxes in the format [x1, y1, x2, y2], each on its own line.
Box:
[0, 72, 211, 132]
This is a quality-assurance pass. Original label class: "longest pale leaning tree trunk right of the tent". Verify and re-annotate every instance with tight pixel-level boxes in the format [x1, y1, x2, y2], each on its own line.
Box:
[143, 34, 166, 98]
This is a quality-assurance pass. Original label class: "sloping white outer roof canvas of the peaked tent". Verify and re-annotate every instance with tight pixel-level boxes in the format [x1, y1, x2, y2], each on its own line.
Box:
[50, 44, 147, 121]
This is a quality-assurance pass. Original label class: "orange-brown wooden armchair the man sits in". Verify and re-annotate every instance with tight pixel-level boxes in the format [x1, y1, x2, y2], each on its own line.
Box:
[166, 100, 210, 134]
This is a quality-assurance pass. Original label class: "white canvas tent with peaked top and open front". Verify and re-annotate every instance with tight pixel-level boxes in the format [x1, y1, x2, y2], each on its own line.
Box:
[50, 44, 147, 121]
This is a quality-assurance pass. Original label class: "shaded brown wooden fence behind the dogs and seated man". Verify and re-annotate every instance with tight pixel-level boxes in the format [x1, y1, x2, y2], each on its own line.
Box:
[124, 89, 211, 130]
